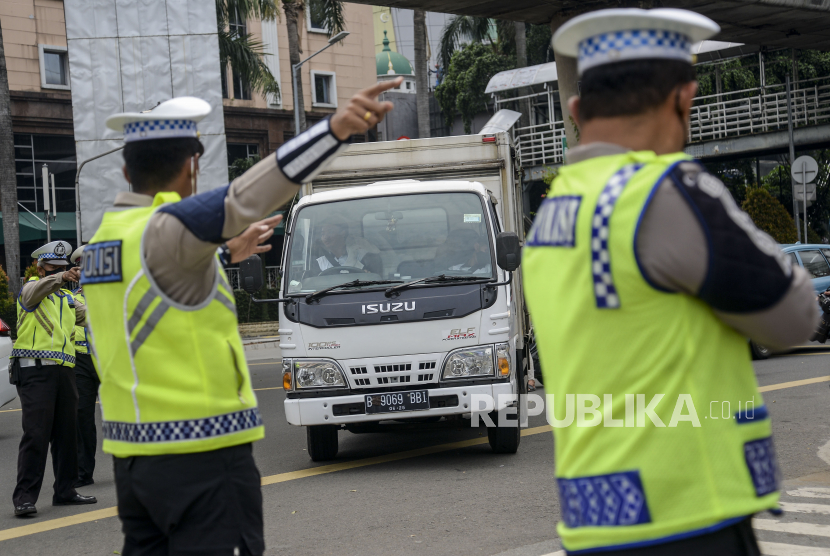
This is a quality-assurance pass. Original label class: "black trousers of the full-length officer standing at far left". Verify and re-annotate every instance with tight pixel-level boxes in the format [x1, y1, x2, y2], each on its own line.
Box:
[12, 365, 78, 506]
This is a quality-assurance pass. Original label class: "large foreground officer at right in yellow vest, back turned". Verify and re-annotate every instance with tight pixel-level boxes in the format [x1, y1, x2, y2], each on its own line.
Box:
[523, 9, 817, 556]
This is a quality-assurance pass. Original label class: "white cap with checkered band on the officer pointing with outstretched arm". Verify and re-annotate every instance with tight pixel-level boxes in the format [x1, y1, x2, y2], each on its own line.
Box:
[107, 97, 210, 143]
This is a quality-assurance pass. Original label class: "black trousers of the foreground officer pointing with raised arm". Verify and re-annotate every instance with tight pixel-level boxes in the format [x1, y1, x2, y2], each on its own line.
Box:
[113, 444, 265, 556]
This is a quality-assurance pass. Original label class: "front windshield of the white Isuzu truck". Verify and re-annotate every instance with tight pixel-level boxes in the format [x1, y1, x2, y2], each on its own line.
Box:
[286, 193, 493, 293]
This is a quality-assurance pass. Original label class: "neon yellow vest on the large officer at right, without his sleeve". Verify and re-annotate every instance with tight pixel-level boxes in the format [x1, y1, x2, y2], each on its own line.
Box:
[522, 152, 778, 553]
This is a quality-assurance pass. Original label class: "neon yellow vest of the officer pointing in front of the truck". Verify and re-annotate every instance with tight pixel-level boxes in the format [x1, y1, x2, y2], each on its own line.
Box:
[82, 194, 263, 457]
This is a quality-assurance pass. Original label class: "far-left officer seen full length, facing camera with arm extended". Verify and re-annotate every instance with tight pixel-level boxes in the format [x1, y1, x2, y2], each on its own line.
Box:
[11, 241, 97, 516]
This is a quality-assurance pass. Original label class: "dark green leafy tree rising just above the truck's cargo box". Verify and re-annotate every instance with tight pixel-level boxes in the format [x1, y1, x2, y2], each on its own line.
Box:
[435, 43, 513, 133]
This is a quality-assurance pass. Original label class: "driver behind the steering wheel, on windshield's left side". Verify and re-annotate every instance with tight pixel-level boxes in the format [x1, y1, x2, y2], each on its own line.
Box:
[314, 215, 382, 275]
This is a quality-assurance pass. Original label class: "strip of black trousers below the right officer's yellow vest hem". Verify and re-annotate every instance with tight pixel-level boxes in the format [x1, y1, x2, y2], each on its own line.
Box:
[580, 517, 761, 556]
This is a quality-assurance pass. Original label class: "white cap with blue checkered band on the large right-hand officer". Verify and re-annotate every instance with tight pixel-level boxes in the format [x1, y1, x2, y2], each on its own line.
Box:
[551, 8, 720, 75]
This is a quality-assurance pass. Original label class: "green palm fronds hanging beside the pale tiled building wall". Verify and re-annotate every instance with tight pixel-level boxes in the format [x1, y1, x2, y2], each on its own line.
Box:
[216, 0, 280, 95]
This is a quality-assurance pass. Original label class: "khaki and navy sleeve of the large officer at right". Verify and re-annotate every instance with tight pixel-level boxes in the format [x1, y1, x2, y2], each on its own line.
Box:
[635, 163, 819, 349]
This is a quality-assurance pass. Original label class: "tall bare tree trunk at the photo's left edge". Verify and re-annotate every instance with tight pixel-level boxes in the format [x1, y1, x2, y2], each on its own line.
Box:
[0, 19, 20, 292]
